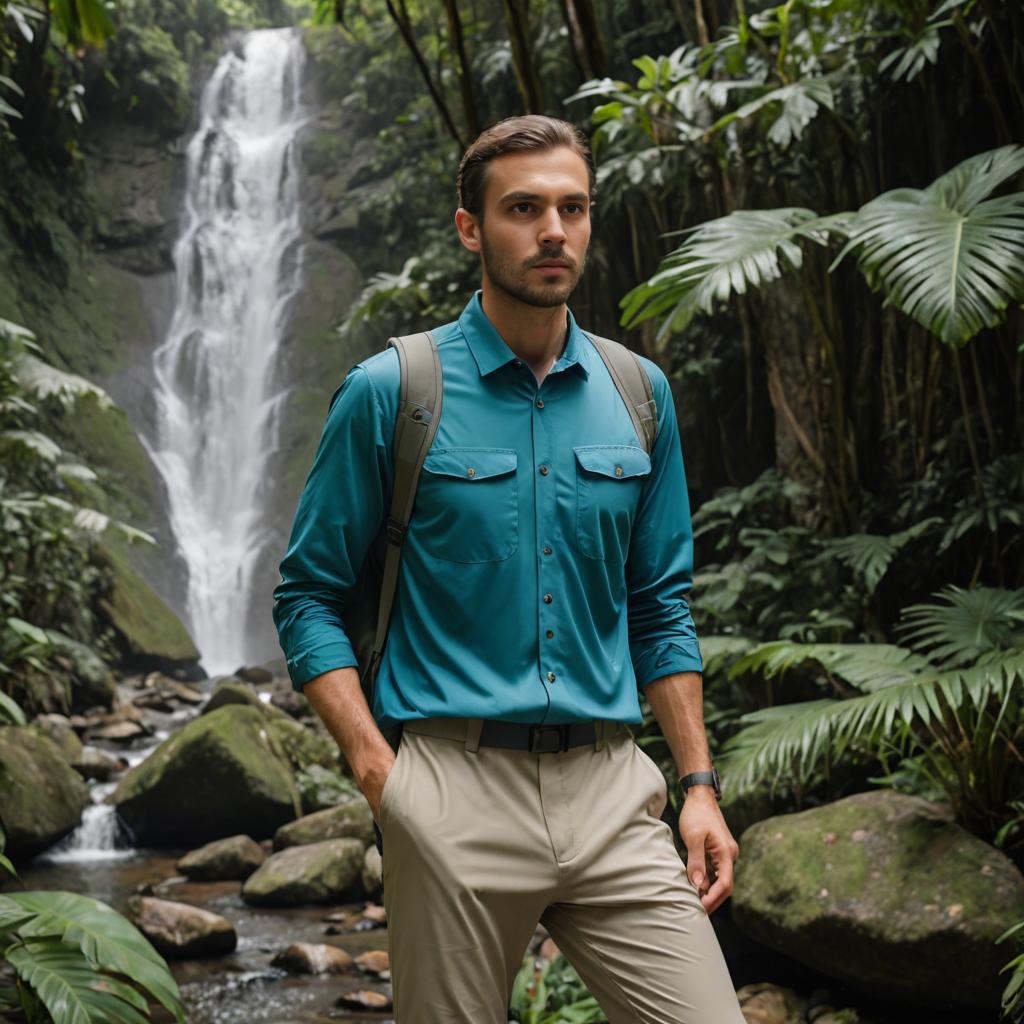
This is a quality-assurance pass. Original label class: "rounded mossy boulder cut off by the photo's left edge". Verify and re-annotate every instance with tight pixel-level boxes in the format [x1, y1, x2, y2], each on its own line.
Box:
[0, 725, 88, 859]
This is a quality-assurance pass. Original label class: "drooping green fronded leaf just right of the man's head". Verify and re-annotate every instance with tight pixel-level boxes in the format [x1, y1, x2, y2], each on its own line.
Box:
[622, 207, 848, 339]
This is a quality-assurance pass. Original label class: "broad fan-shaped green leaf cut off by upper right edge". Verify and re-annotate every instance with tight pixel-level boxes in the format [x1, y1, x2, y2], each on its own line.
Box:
[833, 145, 1024, 345]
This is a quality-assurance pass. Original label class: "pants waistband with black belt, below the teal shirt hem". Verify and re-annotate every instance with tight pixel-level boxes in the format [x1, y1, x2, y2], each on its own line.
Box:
[402, 718, 630, 754]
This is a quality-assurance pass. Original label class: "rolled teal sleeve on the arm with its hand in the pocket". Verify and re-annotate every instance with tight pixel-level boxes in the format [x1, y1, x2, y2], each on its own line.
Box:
[273, 367, 391, 689]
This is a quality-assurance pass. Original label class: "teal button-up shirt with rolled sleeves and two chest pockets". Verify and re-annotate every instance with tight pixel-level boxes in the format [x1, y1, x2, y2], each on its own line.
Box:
[273, 293, 701, 727]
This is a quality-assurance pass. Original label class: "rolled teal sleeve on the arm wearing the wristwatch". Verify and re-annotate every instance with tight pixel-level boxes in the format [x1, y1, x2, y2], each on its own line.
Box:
[626, 360, 702, 688]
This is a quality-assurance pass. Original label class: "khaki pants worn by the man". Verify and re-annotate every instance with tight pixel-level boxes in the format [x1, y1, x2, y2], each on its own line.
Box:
[380, 719, 744, 1024]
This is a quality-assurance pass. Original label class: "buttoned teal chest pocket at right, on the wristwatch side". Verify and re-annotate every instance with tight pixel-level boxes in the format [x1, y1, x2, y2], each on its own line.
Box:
[572, 444, 650, 562]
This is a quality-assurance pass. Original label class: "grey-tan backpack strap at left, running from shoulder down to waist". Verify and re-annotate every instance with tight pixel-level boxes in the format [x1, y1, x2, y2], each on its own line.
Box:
[368, 331, 442, 689]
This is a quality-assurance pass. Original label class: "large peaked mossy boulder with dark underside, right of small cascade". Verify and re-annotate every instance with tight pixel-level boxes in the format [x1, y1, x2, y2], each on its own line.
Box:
[114, 707, 300, 847]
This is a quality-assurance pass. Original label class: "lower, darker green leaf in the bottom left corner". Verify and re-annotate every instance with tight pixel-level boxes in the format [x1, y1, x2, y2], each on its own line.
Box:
[6, 939, 149, 1024]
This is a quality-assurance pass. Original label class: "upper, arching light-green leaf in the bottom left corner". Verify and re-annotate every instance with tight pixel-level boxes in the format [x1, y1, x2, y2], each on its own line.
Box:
[8, 892, 184, 1024]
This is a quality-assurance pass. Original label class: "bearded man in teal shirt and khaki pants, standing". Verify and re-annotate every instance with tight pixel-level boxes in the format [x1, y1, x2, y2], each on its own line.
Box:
[274, 116, 742, 1024]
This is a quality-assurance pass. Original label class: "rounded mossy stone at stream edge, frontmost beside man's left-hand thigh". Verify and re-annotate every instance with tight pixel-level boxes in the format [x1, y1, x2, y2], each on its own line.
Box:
[242, 839, 362, 906]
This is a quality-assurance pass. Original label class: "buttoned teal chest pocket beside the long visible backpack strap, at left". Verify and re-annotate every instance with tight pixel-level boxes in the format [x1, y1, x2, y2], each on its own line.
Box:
[414, 447, 519, 562]
